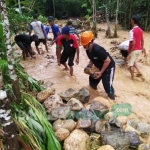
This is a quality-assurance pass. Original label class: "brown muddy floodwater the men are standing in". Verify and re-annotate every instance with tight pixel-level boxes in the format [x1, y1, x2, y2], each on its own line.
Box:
[21, 24, 150, 124]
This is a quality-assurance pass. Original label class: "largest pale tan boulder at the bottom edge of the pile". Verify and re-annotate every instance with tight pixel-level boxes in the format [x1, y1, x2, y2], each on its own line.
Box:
[64, 129, 89, 150]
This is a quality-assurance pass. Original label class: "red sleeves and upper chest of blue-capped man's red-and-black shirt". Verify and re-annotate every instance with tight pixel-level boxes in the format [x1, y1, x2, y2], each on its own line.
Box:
[57, 34, 79, 49]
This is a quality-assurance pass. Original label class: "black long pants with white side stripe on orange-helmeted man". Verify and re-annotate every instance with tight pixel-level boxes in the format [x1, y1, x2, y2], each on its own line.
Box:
[89, 67, 115, 95]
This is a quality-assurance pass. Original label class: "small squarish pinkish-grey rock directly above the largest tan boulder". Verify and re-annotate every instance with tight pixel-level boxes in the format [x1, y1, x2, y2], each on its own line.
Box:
[76, 118, 91, 129]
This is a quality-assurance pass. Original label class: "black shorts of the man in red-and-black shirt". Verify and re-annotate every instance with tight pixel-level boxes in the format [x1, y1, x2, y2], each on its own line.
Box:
[60, 51, 76, 66]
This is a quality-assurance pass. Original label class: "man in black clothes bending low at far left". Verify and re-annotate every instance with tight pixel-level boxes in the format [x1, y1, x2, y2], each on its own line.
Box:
[15, 34, 38, 60]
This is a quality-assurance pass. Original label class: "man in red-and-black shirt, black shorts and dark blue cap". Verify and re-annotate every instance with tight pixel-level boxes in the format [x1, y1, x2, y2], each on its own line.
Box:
[57, 26, 79, 76]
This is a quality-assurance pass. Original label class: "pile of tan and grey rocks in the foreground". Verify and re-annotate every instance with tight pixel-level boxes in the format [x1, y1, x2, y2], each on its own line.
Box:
[37, 83, 150, 150]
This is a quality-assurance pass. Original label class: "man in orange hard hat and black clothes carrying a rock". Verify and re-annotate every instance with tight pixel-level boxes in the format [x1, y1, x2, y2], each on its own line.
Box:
[80, 31, 115, 100]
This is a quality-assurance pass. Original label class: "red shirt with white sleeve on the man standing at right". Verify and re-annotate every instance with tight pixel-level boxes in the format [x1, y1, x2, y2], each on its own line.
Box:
[128, 26, 143, 52]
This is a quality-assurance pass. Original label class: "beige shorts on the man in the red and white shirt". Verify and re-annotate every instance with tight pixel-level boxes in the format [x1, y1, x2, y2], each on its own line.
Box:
[128, 50, 142, 67]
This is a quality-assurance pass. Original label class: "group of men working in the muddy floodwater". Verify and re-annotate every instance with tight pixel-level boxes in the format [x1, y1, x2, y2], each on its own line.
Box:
[15, 15, 145, 100]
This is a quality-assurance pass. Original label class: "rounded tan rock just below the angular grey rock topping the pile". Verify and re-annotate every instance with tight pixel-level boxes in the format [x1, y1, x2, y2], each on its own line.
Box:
[67, 98, 83, 110]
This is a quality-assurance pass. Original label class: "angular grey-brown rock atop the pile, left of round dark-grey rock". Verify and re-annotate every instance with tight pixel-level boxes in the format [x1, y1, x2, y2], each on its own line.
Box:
[58, 88, 78, 102]
